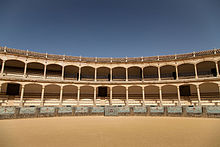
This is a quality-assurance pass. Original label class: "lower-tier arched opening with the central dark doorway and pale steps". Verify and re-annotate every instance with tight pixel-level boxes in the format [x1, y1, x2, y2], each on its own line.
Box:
[96, 86, 110, 106]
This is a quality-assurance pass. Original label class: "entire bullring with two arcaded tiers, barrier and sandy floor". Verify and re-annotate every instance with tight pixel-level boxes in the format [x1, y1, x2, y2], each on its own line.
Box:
[0, 47, 220, 146]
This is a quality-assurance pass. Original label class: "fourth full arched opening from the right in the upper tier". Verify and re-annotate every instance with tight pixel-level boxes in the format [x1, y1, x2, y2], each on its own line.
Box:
[144, 66, 158, 81]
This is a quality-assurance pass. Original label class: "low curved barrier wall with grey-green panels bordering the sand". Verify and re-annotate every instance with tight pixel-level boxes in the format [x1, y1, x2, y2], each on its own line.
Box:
[0, 106, 220, 119]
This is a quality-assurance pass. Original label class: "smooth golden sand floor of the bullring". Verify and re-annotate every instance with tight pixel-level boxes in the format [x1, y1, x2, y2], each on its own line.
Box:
[0, 116, 220, 147]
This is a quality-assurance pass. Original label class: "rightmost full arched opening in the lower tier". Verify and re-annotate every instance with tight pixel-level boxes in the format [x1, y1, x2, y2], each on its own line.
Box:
[199, 83, 219, 100]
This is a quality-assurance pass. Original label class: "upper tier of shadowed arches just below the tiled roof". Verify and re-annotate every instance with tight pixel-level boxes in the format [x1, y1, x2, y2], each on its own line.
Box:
[0, 60, 220, 81]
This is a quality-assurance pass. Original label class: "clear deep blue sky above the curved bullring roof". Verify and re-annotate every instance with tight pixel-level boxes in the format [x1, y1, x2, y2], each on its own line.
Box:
[0, 0, 220, 57]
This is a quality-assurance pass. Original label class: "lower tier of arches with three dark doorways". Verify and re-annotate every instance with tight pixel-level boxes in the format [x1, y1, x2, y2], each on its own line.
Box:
[0, 82, 220, 105]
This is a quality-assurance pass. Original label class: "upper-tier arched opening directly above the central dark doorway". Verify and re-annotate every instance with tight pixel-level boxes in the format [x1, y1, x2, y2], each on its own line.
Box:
[97, 67, 110, 81]
